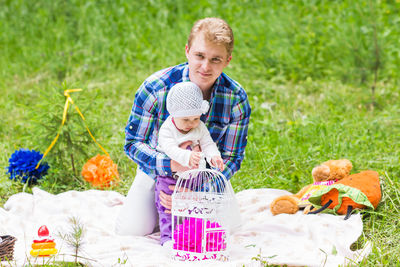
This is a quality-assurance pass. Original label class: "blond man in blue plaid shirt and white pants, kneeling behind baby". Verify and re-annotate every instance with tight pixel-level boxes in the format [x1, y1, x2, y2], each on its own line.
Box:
[116, 18, 251, 239]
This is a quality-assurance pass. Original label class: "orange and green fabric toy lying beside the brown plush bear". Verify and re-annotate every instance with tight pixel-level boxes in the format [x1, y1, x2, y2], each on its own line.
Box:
[309, 170, 382, 220]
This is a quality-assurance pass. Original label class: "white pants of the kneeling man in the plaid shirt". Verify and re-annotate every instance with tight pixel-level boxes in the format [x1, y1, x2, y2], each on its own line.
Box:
[115, 168, 241, 236]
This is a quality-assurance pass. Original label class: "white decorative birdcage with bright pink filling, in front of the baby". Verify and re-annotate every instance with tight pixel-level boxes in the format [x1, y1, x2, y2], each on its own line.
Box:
[171, 169, 234, 261]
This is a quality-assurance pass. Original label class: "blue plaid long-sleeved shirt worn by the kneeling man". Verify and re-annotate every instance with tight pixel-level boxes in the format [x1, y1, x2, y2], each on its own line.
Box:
[124, 63, 251, 179]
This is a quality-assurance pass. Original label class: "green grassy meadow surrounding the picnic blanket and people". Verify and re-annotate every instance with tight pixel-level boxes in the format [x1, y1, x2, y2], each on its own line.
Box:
[0, 0, 400, 266]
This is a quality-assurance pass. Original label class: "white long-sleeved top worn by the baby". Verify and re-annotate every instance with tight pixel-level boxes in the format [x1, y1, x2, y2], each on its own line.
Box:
[157, 116, 221, 167]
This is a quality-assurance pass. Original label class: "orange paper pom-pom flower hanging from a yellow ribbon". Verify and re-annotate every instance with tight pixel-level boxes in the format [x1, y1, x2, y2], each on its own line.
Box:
[82, 155, 119, 188]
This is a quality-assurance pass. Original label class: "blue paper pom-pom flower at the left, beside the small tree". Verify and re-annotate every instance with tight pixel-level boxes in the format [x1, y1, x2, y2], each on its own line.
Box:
[7, 148, 50, 184]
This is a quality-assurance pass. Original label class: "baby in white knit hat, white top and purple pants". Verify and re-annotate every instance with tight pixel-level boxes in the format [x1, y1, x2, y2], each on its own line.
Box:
[155, 82, 225, 245]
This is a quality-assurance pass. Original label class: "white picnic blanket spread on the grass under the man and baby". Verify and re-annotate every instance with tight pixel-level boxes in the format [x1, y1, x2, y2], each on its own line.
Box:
[0, 188, 371, 266]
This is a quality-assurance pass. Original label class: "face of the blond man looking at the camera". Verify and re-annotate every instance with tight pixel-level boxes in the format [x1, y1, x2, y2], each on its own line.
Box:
[186, 33, 232, 91]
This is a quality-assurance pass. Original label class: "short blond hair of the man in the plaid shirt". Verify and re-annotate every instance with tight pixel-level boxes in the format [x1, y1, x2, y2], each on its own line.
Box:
[188, 18, 233, 56]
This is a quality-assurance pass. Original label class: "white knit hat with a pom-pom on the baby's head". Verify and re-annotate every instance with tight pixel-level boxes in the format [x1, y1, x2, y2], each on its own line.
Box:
[167, 82, 210, 118]
